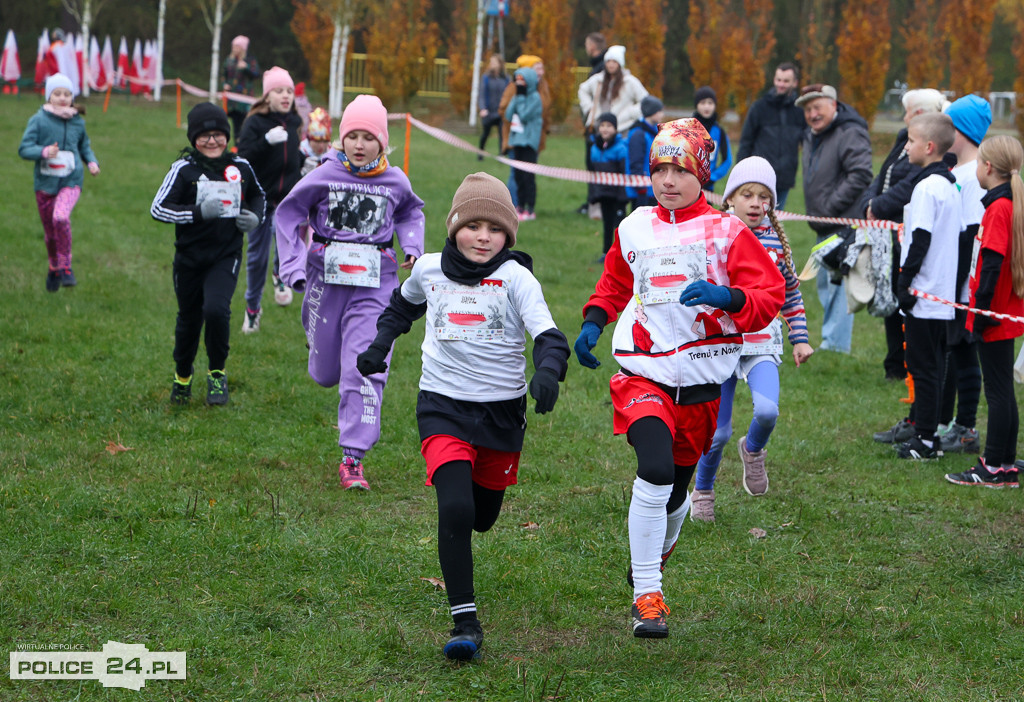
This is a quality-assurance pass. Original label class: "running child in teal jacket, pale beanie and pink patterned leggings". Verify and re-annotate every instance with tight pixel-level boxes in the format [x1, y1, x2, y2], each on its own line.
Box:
[17, 73, 99, 293]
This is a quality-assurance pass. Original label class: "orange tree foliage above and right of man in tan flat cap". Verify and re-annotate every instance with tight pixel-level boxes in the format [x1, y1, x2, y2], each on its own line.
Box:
[836, 0, 890, 126]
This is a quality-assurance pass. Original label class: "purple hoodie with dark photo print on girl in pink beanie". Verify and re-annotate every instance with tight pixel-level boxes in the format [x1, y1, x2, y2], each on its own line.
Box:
[276, 153, 425, 291]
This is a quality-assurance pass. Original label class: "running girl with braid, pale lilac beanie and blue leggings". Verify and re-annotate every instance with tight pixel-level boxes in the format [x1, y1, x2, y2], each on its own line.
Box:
[690, 156, 814, 522]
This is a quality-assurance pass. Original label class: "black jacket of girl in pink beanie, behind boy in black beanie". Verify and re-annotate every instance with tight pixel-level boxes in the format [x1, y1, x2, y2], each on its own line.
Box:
[236, 109, 305, 207]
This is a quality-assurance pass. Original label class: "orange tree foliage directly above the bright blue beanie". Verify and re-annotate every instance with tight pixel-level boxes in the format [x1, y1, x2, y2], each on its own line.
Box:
[943, 0, 995, 95]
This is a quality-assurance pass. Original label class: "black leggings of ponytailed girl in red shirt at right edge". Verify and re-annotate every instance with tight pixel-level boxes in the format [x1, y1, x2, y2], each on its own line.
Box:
[978, 339, 1020, 469]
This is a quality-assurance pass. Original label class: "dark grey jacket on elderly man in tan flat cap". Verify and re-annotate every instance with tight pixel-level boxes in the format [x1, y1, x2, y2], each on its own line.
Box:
[801, 102, 871, 235]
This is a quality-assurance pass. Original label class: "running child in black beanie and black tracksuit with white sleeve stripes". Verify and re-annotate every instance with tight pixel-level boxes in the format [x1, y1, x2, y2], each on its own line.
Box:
[150, 102, 265, 404]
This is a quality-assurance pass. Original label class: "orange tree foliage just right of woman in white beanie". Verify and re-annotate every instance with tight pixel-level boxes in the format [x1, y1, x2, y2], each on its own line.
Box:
[611, 0, 668, 95]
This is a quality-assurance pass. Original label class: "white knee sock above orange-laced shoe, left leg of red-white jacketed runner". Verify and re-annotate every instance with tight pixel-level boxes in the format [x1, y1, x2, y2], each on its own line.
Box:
[629, 478, 672, 600]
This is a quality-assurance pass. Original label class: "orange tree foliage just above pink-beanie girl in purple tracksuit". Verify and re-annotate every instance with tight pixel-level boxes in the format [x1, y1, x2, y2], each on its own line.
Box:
[366, 0, 439, 109]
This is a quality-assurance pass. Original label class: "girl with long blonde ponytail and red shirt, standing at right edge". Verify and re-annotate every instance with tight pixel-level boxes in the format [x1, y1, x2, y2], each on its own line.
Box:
[946, 135, 1024, 488]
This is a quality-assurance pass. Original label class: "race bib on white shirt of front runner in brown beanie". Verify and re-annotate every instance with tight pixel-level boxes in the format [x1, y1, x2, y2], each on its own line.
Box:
[431, 284, 508, 342]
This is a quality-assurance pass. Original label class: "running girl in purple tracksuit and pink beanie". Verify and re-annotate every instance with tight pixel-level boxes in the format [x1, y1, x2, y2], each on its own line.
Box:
[278, 95, 424, 490]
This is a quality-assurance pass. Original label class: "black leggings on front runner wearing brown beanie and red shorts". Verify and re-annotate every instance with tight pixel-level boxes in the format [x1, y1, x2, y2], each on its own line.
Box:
[433, 460, 505, 607]
